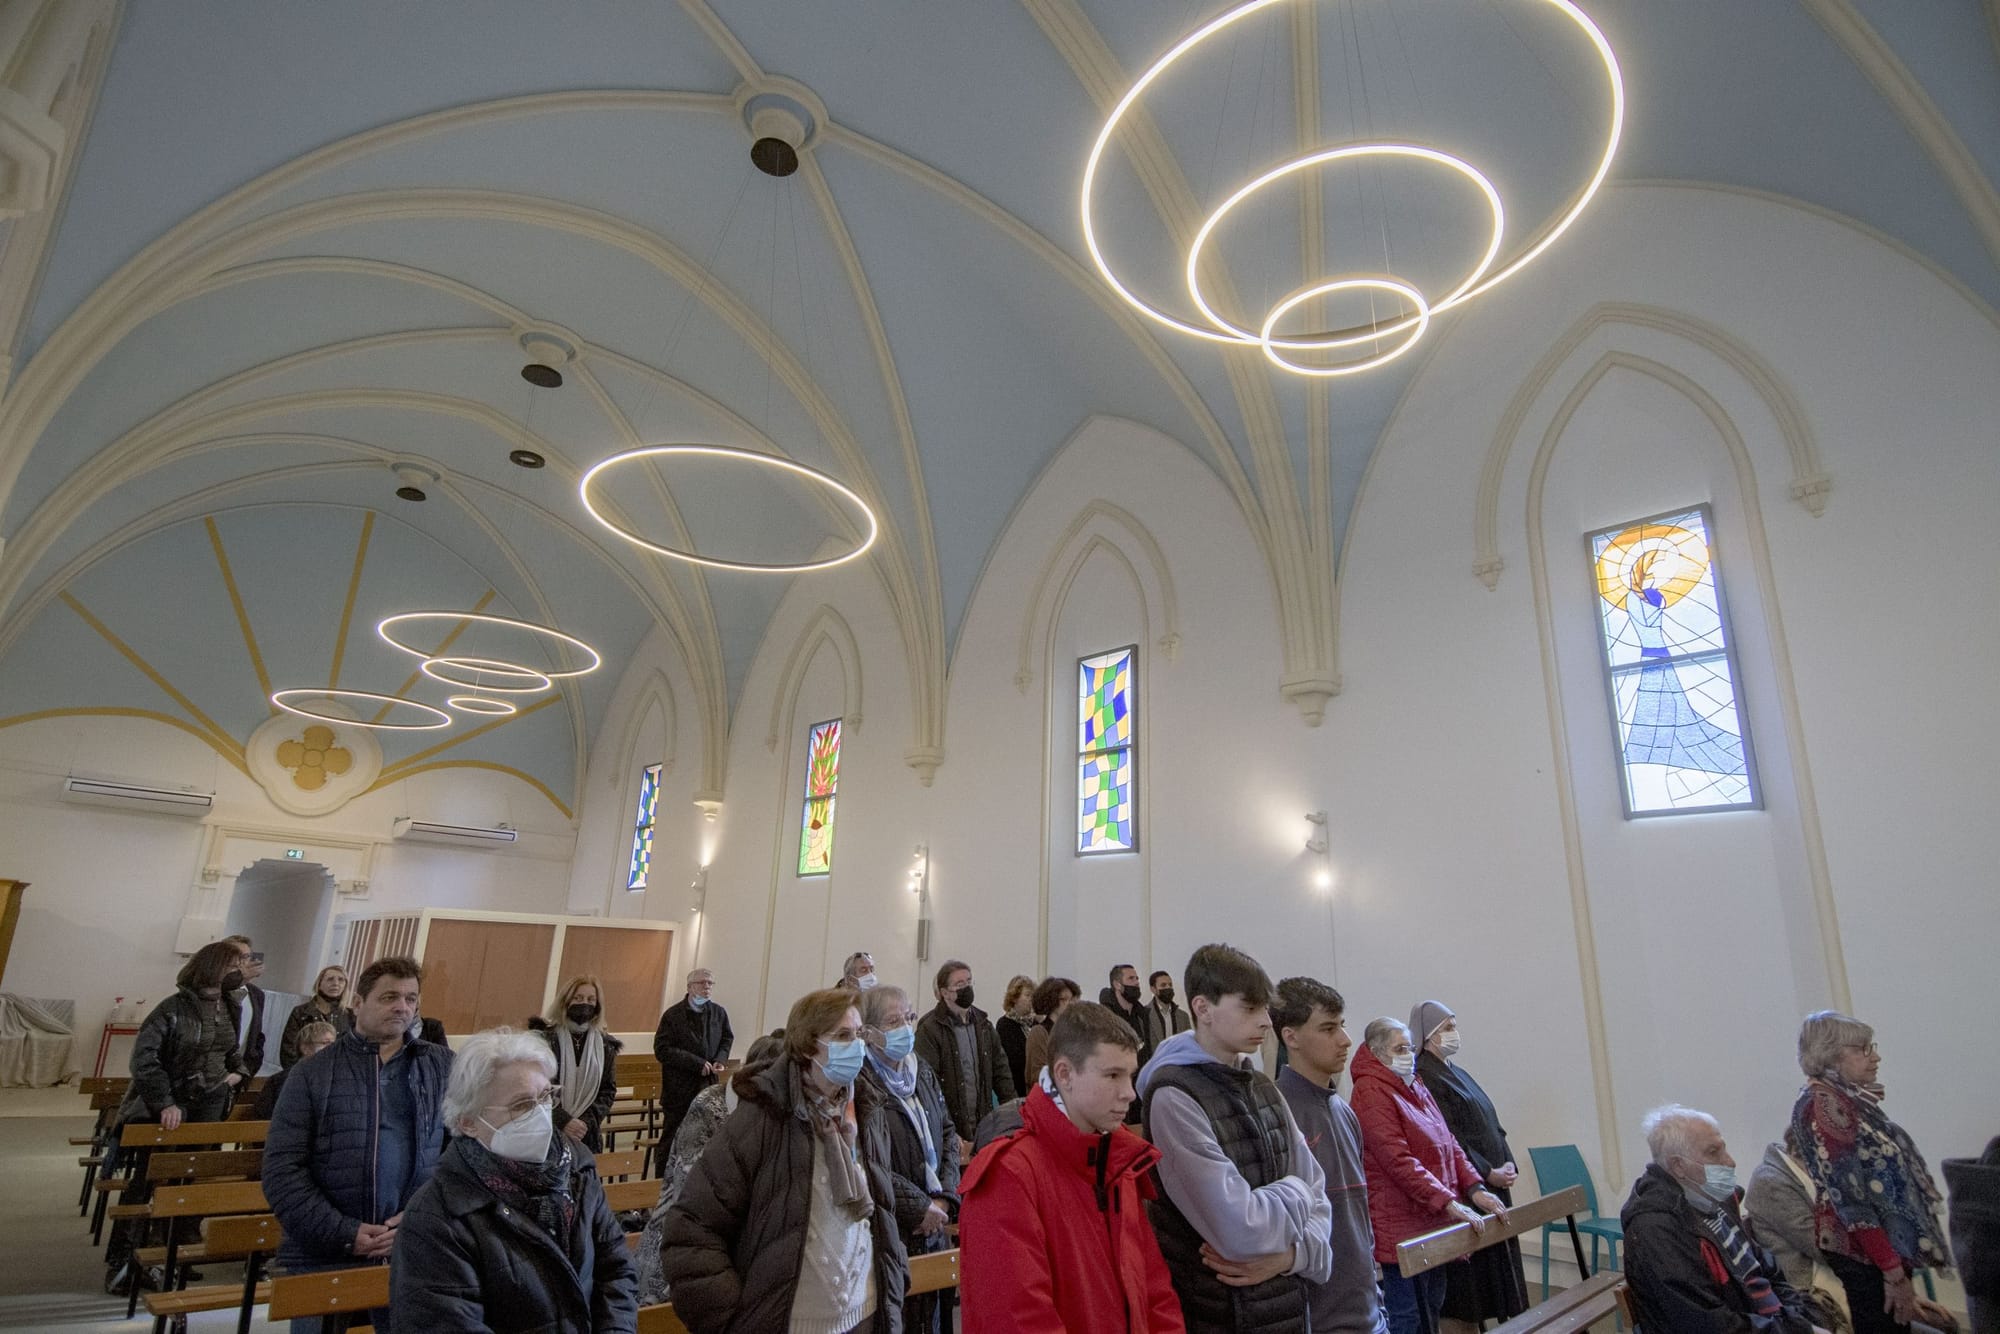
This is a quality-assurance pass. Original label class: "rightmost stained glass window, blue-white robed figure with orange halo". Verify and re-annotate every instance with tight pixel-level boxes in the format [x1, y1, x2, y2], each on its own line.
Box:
[1588, 506, 1758, 816]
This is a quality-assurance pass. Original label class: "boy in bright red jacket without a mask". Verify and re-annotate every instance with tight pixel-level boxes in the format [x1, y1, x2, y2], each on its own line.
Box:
[958, 1002, 1186, 1334]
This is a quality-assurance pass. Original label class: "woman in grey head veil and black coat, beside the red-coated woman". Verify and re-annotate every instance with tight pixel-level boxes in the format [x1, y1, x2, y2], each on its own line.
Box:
[1410, 1000, 1530, 1320]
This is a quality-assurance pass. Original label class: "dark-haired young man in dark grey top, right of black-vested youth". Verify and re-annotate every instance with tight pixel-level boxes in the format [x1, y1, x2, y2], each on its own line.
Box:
[1270, 978, 1388, 1334]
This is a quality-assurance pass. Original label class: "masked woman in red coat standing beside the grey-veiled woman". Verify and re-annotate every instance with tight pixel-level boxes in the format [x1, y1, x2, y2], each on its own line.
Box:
[1354, 1018, 1506, 1334]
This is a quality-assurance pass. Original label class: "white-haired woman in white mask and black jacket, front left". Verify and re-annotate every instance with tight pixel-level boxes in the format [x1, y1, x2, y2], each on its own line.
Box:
[390, 1028, 638, 1334]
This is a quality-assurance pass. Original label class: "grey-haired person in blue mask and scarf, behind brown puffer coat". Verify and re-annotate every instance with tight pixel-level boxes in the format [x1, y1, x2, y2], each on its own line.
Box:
[860, 982, 958, 1334]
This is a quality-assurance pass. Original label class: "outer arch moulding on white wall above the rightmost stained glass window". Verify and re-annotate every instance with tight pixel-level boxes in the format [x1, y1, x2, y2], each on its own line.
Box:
[1472, 302, 1832, 588]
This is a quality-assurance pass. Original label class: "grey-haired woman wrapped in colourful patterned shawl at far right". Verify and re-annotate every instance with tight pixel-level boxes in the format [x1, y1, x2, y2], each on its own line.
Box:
[1792, 1010, 1952, 1334]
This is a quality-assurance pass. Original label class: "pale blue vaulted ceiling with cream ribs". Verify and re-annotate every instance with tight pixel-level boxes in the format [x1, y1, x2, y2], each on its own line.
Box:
[0, 0, 2000, 802]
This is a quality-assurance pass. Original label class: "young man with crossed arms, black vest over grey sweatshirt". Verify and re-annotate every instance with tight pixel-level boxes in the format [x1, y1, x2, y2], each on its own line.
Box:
[1138, 944, 1332, 1334]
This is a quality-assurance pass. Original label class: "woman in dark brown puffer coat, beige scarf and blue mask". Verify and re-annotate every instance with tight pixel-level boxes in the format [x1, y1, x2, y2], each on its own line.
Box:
[660, 990, 910, 1334]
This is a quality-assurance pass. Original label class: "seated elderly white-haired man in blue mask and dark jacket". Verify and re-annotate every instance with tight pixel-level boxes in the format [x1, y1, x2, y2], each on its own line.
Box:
[1620, 1106, 1826, 1334]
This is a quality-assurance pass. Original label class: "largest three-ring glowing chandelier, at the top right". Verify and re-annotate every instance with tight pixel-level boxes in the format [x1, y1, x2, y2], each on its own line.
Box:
[1082, 0, 1624, 376]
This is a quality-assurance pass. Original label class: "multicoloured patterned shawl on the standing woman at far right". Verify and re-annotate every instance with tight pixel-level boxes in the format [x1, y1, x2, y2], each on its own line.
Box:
[1792, 1072, 1952, 1270]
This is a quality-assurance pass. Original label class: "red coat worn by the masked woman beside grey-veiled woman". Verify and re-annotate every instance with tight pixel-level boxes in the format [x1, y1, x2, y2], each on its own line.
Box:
[1350, 1046, 1480, 1264]
